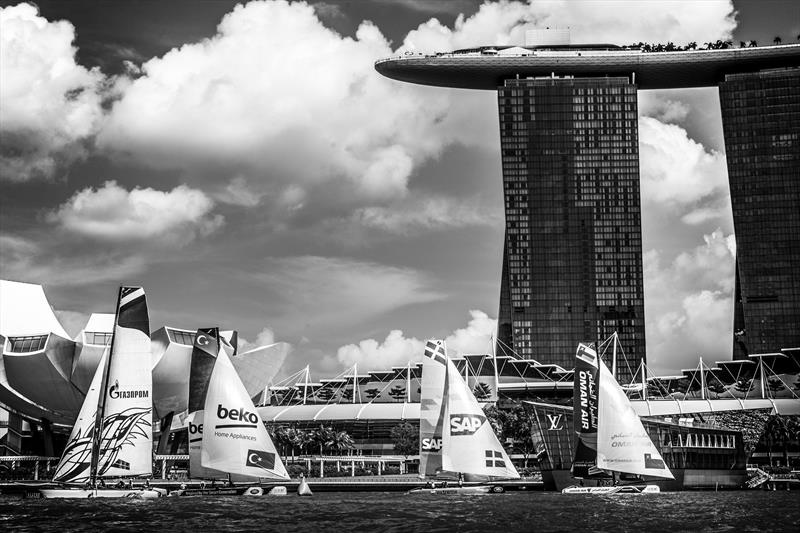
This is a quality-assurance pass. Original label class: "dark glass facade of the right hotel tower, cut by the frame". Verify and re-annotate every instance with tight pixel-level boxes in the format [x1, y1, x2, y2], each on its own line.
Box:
[719, 68, 800, 358]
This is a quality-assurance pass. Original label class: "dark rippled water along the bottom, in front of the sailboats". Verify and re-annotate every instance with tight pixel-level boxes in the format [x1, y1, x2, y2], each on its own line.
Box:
[0, 491, 800, 533]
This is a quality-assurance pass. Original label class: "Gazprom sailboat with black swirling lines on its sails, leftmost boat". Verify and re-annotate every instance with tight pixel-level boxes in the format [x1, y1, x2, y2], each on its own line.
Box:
[39, 287, 164, 498]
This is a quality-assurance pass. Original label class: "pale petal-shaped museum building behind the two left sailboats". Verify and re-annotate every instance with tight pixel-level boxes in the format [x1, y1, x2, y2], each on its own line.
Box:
[0, 280, 290, 455]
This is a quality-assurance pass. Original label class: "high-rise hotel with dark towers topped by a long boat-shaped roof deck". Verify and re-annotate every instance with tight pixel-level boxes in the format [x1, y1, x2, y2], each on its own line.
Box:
[375, 30, 800, 381]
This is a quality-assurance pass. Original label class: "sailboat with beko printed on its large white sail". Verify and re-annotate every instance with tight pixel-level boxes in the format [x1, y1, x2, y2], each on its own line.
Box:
[173, 328, 289, 495]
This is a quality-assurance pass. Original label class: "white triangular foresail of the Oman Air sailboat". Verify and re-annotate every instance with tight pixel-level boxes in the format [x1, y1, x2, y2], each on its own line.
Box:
[597, 359, 675, 479]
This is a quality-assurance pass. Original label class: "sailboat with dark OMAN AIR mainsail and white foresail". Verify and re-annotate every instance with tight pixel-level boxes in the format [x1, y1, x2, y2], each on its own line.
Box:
[561, 344, 674, 494]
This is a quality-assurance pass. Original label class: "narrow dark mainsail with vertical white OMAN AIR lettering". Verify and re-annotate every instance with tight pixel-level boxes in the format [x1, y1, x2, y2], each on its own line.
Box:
[572, 344, 598, 478]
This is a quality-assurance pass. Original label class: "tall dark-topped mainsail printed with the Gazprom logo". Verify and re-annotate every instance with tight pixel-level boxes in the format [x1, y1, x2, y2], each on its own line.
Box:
[97, 287, 153, 477]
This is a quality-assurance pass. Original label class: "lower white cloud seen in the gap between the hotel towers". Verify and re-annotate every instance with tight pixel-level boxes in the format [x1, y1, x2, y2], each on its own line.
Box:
[644, 230, 736, 372]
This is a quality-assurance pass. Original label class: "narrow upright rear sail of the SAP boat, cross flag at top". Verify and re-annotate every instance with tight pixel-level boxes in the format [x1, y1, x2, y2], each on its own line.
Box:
[419, 340, 447, 478]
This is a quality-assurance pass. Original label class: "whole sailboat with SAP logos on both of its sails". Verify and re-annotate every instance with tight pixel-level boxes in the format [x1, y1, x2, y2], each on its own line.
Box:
[411, 340, 519, 494]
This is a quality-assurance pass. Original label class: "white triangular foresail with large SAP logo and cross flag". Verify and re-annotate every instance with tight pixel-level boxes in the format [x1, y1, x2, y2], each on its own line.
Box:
[442, 352, 519, 480]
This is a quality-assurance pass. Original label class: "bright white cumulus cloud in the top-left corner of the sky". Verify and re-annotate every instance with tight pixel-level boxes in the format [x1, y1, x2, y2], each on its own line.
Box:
[0, 4, 104, 181]
